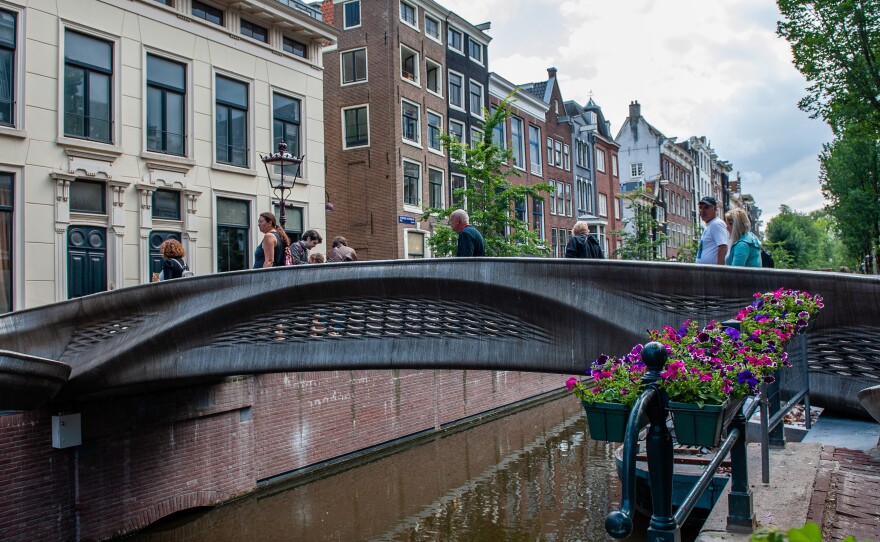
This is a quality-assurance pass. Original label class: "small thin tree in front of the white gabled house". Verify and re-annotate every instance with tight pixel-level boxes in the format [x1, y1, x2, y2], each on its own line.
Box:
[608, 189, 668, 261]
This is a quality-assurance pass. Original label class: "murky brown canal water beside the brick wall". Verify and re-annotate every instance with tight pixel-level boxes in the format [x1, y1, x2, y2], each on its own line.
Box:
[128, 397, 646, 542]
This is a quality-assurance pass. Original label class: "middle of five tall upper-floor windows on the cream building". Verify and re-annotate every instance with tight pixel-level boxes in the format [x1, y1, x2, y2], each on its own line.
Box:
[147, 55, 186, 156]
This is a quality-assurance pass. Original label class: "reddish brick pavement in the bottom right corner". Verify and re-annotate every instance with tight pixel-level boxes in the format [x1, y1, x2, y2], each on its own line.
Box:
[807, 446, 880, 542]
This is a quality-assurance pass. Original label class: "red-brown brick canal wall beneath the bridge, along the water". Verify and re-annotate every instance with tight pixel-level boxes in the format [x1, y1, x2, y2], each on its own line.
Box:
[0, 370, 564, 540]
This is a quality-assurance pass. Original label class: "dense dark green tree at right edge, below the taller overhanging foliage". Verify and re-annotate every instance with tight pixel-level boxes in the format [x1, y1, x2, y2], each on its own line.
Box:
[819, 130, 880, 274]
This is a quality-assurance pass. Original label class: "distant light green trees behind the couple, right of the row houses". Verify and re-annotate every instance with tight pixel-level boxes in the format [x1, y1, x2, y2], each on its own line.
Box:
[764, 205, 846, 270]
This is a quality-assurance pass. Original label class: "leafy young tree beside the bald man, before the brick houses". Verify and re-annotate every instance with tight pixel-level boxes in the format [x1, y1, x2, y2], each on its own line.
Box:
[422, 94, 550, 256]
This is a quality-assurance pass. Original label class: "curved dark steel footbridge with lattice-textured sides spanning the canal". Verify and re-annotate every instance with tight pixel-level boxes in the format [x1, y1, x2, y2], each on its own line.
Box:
[0, 258, 880, 412]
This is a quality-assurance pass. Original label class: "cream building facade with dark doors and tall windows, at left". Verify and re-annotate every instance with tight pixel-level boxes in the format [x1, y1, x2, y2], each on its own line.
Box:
[0, 0, 336, 311]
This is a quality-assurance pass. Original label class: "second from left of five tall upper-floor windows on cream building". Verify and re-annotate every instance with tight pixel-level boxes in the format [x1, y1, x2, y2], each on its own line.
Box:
[64, 30, 113, 143]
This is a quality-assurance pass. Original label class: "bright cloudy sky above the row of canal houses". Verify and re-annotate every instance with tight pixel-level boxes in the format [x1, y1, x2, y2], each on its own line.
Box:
[441, 0, 832, 223]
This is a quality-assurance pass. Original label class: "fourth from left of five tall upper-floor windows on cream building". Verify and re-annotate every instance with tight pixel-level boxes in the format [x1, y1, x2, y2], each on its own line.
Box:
[216, 75, 248, 167]
